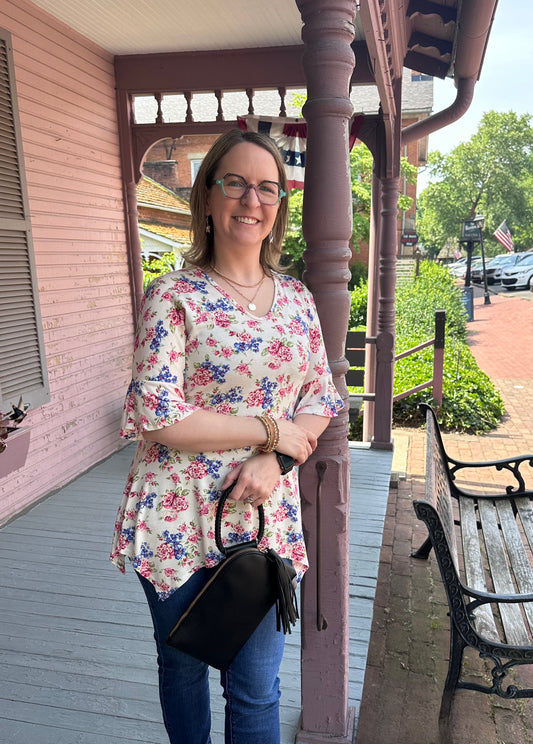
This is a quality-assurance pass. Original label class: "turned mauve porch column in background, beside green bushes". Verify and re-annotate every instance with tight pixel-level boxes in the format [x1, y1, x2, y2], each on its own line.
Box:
[372, 176, 400, 449]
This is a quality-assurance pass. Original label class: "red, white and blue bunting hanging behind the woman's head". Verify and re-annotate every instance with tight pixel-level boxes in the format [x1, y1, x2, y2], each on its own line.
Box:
[237, 114, 363, 189]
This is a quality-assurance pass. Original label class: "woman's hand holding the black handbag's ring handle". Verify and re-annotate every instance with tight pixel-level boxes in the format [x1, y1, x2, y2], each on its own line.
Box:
[222, 452, 281, 506]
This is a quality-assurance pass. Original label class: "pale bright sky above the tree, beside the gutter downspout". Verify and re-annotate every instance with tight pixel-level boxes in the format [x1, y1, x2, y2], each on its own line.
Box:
[418, 0, 533, 191]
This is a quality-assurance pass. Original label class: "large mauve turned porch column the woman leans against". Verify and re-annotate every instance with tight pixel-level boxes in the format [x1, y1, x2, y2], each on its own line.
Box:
[296, 0, 355, 744]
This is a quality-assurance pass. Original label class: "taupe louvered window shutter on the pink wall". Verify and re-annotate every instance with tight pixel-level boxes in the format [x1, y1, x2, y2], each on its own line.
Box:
[0, 29, 50, 413]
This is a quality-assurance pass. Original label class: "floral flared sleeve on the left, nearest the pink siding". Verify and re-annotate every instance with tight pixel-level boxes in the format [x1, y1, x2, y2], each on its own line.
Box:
[120, 277, 198, 439]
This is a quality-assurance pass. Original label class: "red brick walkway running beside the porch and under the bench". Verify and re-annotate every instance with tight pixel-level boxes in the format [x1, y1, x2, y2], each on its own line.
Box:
[357, 295, 533, 744]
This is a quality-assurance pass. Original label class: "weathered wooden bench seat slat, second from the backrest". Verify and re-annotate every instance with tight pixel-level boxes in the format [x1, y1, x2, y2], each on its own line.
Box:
[478, 499, 530, 646]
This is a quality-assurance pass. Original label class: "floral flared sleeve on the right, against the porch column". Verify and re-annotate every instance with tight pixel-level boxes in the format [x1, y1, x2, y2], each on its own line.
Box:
[294, 290, 344, 418]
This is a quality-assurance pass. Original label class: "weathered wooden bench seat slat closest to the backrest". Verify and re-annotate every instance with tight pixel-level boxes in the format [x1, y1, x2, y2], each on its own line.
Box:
[459, 499, 501, 642]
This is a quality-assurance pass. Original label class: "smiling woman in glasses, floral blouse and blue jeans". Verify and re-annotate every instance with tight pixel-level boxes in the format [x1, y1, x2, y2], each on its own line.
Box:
[111, 130, 342, 744]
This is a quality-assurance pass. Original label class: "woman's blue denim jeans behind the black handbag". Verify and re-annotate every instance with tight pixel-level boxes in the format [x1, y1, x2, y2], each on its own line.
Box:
[136, 568, 285, 744]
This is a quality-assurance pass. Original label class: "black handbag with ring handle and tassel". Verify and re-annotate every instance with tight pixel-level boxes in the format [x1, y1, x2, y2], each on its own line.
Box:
[167, 486, 299, 670]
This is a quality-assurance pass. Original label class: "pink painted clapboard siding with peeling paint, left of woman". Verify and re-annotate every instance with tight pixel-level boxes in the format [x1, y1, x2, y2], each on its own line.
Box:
[0, 0, 133, 523]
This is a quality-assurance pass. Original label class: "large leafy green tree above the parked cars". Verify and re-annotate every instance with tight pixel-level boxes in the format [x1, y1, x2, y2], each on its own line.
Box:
[417, 111, 533, 255]
